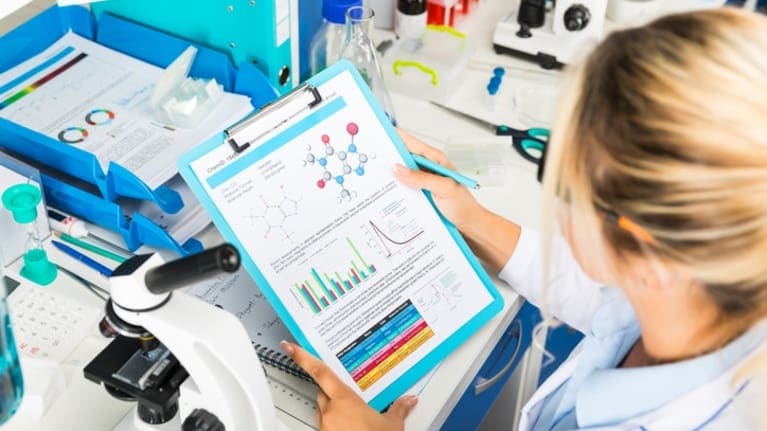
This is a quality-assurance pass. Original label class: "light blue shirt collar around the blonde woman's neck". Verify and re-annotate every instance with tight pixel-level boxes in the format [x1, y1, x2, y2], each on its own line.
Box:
[576, 321, 767, 428]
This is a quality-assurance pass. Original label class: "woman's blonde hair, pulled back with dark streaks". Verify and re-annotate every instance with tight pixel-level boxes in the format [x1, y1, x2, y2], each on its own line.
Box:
[544, 8, 767, 378]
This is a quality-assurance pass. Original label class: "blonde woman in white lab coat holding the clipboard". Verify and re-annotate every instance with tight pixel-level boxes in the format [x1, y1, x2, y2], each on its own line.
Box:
[284, 9, 767, 430]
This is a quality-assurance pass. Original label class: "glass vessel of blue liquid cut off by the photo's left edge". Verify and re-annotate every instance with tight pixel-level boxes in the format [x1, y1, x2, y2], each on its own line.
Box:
[0, 274, 24, 425]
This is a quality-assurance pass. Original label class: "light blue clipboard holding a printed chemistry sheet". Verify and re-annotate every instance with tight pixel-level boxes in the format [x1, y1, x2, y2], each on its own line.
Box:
[179, 61, 503, 410]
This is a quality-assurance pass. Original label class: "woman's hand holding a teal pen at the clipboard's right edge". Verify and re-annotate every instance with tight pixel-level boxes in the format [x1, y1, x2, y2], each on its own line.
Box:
[394, 130, 485, 235]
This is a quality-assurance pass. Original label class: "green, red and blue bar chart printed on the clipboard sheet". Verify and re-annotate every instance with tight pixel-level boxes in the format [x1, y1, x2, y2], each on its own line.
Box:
[294, 237, 377, 315]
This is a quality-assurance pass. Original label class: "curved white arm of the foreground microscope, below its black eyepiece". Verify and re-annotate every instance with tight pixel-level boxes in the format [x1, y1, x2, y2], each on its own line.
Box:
[115, 291, 284, 431]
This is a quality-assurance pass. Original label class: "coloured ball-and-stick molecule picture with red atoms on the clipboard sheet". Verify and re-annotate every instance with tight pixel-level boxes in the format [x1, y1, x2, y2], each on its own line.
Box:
[303, 123, 375, 203]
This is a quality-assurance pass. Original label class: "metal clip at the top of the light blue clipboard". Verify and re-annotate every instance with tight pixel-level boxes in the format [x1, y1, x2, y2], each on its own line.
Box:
[224, 84, 322, 153]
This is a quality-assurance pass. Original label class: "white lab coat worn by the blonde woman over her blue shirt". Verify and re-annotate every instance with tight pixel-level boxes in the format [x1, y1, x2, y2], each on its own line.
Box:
[500, 230, 767, 431]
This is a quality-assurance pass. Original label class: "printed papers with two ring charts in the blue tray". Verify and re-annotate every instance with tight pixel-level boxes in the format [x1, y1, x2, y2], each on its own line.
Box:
[0, 33, 252, 189]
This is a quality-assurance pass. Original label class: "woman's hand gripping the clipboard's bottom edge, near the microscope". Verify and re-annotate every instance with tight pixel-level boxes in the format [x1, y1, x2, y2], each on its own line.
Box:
[281, 341, 418, 431]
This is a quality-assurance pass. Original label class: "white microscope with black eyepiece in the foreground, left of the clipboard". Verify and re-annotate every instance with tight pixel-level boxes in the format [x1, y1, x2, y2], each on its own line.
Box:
[84, 244, 285, 431]
